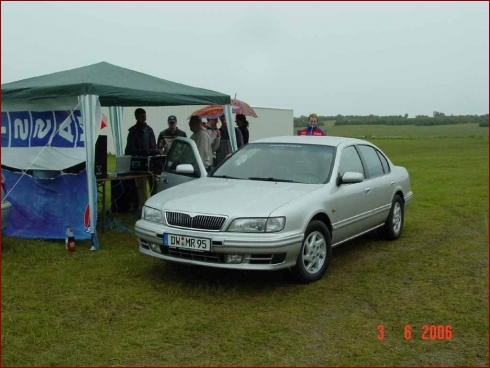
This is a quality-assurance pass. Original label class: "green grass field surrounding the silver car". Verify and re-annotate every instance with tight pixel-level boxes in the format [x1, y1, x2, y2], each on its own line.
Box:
[2, 126, 488, 366]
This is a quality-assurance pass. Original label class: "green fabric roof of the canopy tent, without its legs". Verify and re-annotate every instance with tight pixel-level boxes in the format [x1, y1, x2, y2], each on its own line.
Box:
[2, 62, 230, 106]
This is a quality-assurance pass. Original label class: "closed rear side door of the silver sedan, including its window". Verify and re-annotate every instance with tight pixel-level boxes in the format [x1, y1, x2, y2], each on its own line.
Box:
[357, 144, 395, 227]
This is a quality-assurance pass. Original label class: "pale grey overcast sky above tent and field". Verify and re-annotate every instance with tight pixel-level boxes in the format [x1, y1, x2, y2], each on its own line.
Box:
[1, 2, 489, 117]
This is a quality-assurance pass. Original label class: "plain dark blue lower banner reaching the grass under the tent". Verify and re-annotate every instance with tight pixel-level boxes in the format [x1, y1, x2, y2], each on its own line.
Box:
[2, 168, 92, 240]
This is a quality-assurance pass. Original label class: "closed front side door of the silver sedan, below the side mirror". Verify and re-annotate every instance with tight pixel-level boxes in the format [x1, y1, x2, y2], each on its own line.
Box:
[333, 145, 373, 244]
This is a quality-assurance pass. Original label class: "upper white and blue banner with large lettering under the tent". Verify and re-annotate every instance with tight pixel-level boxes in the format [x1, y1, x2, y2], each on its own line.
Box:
[1, 98, 101, 170]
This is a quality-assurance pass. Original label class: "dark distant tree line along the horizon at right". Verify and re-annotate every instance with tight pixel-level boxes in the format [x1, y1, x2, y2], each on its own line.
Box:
[294, 111, 488, 128]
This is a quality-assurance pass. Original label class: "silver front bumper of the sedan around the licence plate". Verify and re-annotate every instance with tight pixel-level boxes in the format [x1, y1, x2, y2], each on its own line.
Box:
[135, 219, 304, 270]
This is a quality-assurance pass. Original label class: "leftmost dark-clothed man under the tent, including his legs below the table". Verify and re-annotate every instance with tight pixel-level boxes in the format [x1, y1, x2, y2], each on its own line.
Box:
[124, 108, 157, 210]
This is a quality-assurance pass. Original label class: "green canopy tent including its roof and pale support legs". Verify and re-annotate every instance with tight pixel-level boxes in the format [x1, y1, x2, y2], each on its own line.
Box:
[2, 62, 236, 249]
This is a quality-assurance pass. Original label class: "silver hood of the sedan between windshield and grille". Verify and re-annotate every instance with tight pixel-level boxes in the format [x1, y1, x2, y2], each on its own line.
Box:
[146, 178, 324, 217]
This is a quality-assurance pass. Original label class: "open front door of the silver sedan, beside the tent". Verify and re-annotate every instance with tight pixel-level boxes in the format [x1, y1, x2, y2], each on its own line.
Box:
[158, 137, 208, 192]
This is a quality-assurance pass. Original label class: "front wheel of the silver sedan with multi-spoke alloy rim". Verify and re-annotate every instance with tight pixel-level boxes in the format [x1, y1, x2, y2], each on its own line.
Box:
[293, 221, 332, 284]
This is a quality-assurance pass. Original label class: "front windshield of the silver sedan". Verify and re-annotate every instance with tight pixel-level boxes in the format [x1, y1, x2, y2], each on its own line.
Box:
[211, 143, 336, 184]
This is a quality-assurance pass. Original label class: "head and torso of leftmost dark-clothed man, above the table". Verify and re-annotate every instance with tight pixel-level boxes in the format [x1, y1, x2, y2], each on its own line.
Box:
[124, 108, 157, 156]
